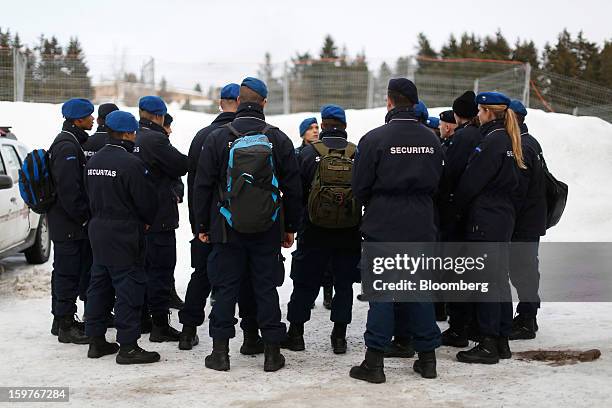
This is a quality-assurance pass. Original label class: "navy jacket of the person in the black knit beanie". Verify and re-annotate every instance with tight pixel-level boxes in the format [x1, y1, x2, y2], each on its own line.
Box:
[436, 122, 483, 241]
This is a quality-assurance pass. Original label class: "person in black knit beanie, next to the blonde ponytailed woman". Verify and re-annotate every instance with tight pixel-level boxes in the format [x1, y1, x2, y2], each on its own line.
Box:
[437, 91, 483, 347]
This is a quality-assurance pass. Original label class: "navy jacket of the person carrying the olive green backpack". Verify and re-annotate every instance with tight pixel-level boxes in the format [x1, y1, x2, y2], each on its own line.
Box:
[298, 129, 361, 250]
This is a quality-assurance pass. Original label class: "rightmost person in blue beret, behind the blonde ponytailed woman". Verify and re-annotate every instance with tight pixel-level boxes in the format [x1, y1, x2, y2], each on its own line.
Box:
[509, 100, 547, 340]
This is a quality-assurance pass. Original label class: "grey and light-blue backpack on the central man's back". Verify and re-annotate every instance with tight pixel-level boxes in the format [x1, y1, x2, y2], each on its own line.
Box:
[219, 123, 281, 233]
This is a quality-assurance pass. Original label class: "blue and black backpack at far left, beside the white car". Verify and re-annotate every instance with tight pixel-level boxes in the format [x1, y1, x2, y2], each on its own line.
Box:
[19, 149, 55, 214]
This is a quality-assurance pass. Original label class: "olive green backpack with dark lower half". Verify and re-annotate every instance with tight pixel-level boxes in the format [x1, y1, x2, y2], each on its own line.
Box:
[308, 141, 361, 228]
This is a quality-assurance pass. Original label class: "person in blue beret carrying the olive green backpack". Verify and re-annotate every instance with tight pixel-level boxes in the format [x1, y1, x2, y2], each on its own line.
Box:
[283, 105, 361, 354]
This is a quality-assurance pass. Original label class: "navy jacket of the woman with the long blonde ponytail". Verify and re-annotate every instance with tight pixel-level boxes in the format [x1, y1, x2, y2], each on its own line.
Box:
[454, 120, 519, 242]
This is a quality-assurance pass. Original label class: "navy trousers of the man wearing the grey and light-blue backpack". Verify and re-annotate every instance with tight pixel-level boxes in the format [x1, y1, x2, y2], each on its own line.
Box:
[208, 240, 286, 344]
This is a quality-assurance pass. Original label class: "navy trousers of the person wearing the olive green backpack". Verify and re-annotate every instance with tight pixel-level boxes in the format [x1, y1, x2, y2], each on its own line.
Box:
[287, 243, 361, 324]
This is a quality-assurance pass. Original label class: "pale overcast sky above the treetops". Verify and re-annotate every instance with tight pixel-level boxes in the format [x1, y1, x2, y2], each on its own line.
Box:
[0, 0, 612, 86]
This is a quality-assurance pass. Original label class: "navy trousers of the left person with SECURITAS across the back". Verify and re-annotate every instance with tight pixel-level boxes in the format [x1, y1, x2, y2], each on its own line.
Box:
[85, 265, 146, 344]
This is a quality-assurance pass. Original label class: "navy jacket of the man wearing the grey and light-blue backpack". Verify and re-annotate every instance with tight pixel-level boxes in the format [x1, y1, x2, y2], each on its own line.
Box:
[193, 103, 302, 243]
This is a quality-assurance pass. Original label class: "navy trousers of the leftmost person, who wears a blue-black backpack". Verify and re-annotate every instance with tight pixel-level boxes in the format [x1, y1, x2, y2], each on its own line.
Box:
[51, 239, 93, 318]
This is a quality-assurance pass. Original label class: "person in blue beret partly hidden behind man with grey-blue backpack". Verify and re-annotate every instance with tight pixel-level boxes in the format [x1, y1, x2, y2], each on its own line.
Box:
[179, 83, 264, 355]
